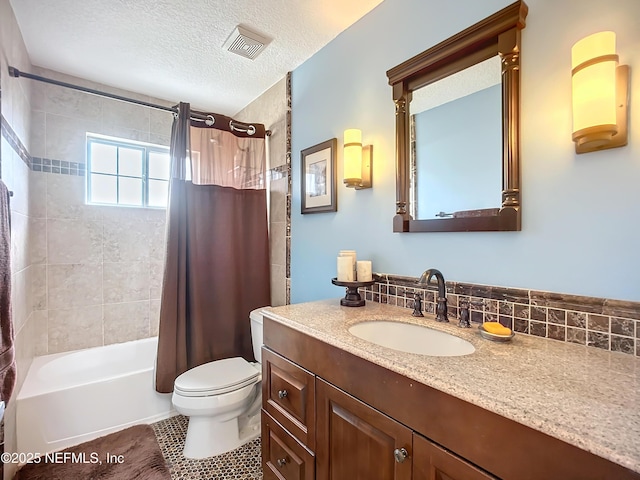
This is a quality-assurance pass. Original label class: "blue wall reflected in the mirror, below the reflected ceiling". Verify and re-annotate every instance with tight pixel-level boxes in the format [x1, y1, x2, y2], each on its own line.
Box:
[414, 85, 502, 218]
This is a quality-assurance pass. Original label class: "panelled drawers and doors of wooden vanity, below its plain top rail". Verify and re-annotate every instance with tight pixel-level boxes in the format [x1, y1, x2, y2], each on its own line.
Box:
[262, 348, 495, 480]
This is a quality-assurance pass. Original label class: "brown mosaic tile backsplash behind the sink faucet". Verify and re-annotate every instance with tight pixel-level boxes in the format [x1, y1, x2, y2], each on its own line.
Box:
[360, 274, 640, 356]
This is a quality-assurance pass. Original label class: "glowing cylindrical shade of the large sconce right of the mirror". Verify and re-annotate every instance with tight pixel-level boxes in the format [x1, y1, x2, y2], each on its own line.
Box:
[571, 32, 618, 149]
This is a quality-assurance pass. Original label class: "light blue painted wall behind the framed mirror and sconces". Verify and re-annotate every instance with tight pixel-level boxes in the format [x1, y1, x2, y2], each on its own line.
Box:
[291, 0, 640, 303]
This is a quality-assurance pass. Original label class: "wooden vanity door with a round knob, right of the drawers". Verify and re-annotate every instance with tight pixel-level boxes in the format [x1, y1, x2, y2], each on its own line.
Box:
[316, 378, 412, 480]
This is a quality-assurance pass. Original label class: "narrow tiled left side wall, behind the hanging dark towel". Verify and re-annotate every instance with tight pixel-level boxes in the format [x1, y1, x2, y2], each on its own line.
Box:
[0, 0, 46, 478]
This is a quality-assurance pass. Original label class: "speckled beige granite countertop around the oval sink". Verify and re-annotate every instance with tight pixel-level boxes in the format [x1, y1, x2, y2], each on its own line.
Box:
[265, 299, 640, 472]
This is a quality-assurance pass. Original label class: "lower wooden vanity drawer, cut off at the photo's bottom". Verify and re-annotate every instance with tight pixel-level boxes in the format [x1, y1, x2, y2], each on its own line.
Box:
[262, 410, 315, 480]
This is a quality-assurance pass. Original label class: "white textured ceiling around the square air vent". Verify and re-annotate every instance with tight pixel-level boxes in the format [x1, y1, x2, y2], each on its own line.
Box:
[10, 0, 382, 115]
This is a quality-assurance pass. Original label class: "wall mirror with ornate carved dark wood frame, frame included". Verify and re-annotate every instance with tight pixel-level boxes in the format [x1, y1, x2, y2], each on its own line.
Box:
[387, 1, 528, 232]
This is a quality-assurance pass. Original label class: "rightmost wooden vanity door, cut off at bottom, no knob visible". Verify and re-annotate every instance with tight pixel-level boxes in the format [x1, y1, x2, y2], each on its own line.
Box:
[413, 433, 496, 480]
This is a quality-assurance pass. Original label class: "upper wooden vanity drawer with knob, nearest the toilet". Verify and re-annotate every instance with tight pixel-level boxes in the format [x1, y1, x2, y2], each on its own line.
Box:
[262, 347, 315, 451]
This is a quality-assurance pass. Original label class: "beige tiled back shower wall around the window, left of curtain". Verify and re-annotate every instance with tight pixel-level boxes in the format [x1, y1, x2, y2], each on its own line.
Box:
[28, 69, 172, 353]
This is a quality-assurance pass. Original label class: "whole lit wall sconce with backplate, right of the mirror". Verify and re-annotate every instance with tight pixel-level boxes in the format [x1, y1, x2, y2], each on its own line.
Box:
[571, 32, 629, 153]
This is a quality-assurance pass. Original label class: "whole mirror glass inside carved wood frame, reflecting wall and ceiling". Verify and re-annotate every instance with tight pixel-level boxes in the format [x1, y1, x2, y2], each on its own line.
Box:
[409, 55, 502, 219]
